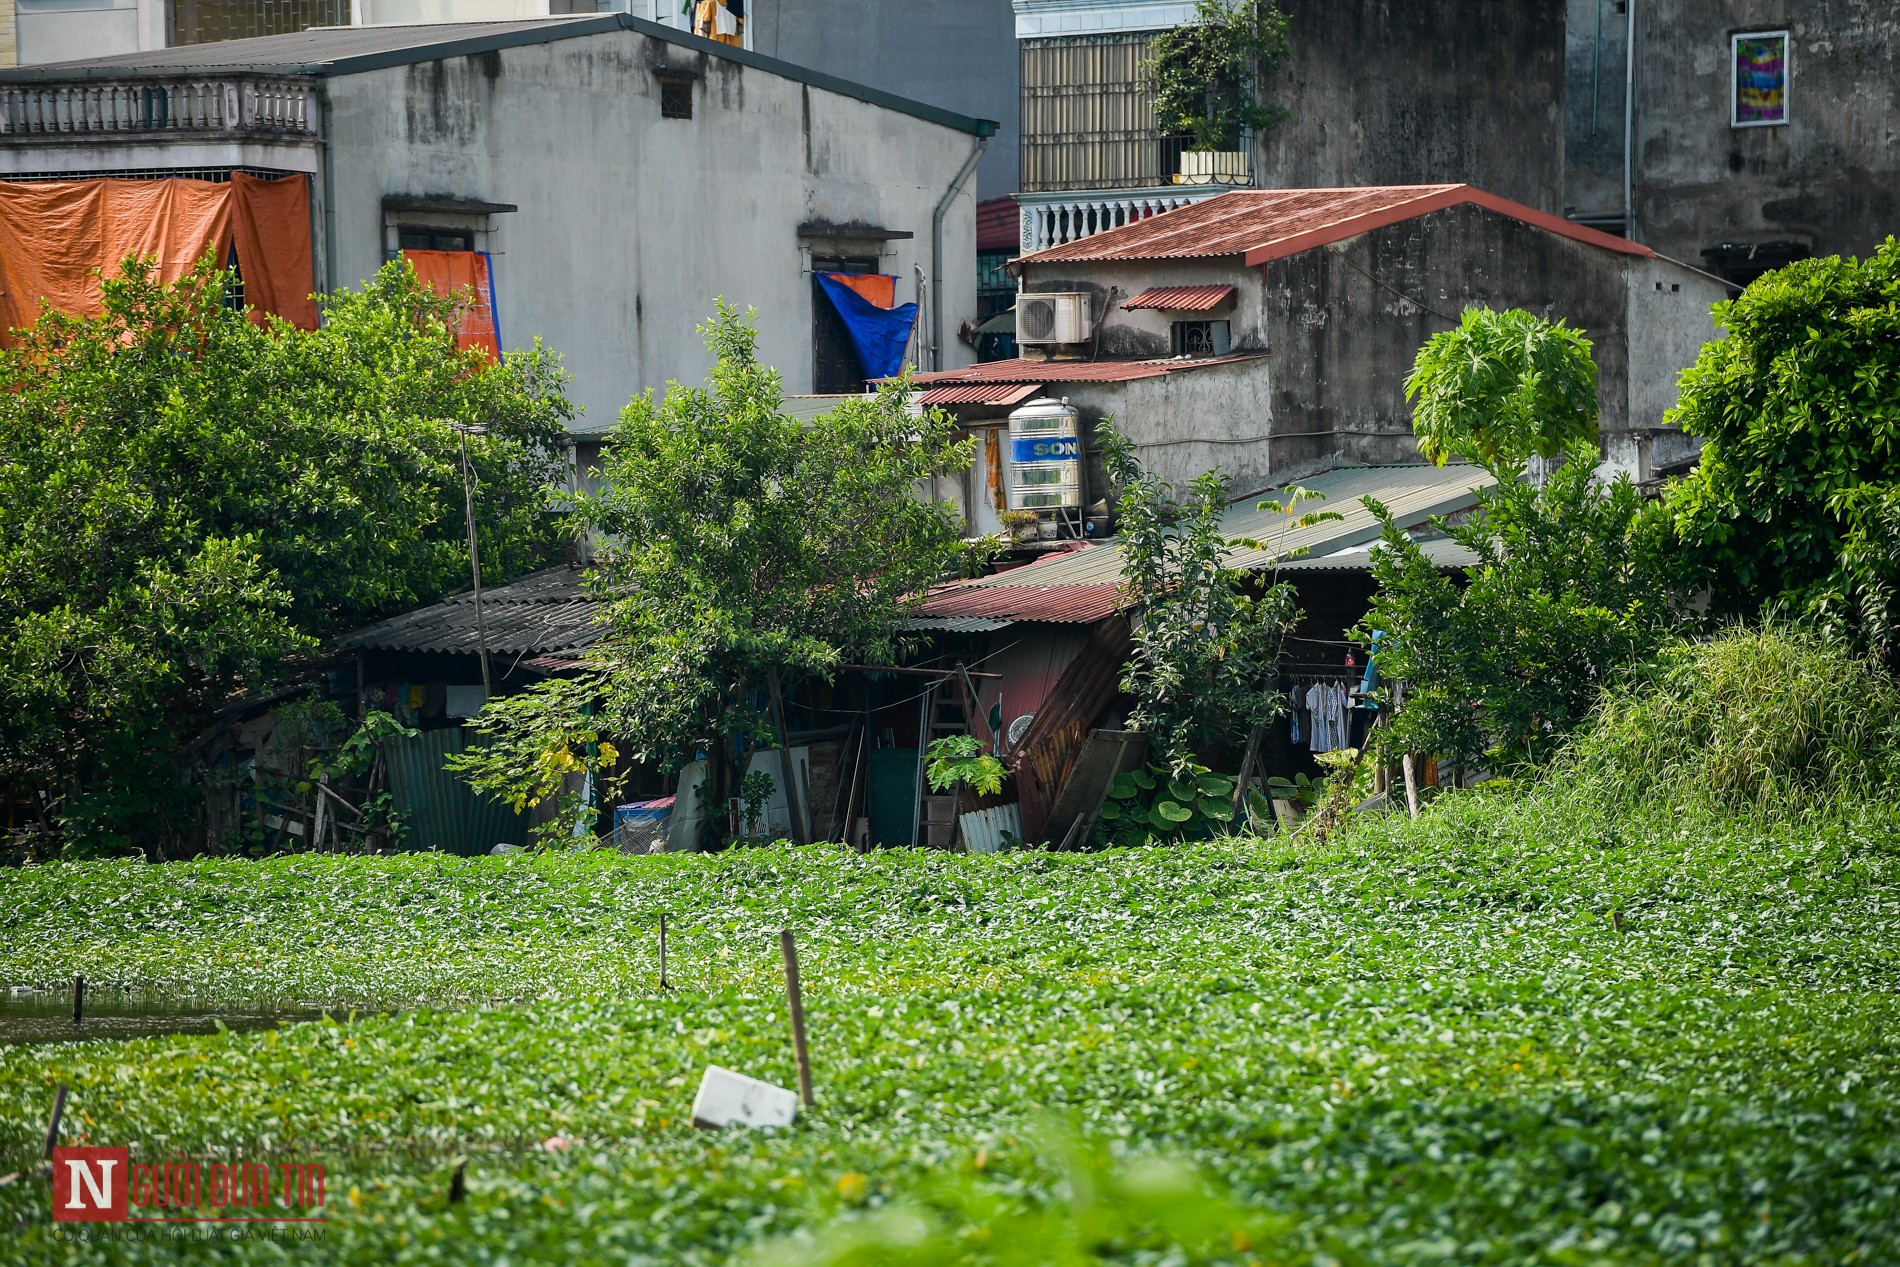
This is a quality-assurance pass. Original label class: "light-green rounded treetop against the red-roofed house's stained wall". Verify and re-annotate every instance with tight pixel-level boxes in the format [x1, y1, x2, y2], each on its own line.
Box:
[1406, 308, 1596, 465]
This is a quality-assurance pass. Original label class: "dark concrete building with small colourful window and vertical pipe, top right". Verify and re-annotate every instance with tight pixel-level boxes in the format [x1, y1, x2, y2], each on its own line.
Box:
[1564, 0, 1900, 281]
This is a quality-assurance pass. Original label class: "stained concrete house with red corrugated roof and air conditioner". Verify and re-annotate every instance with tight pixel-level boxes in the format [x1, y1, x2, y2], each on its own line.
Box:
[918, 184, 1729, 513]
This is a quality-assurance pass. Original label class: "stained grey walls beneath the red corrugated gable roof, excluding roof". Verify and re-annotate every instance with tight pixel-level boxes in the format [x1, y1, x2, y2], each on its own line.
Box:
[1022, 205, 1729, 490]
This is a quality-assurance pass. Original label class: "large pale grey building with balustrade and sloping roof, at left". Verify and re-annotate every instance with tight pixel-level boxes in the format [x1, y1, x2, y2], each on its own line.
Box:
[0, 15, 994, 429]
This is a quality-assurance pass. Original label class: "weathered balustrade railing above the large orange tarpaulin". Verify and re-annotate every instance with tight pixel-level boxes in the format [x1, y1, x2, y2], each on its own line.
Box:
[0, 76, 317, 137]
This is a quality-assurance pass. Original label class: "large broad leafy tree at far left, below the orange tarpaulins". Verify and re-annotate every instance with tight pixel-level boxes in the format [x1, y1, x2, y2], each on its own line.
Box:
[0, 260, 570, 853]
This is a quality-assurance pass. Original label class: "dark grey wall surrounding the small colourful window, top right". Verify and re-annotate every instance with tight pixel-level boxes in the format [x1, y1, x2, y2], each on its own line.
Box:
[1636, 0, 1900, 264]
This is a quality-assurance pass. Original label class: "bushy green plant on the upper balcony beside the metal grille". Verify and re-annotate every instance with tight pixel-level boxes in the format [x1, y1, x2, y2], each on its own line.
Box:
[1146, 0, 1288, 150]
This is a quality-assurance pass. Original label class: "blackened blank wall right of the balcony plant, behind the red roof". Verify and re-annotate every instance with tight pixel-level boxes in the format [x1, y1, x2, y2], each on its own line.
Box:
[1254, 0, 1564, 213]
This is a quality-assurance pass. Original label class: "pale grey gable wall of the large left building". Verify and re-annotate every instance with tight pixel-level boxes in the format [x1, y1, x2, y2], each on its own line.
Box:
[331, 30, 977, 427]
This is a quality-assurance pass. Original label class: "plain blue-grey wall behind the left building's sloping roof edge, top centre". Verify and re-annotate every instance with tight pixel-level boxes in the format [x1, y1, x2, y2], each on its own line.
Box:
[751, 0, 1022, 198]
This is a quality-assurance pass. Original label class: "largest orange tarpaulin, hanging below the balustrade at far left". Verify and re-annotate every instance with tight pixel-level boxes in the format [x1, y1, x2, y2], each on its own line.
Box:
[0, 173, 317, 344]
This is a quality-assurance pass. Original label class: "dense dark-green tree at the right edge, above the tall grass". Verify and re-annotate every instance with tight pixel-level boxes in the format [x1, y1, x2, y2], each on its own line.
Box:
[1664, 237, 1900, 653]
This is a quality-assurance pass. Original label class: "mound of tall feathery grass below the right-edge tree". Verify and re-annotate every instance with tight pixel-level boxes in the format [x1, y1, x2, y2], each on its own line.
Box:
[1568, 625, 1900, 821]
